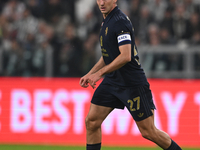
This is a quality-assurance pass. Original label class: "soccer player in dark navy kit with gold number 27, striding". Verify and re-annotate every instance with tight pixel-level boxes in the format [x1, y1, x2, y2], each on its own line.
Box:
[79, 0, 181, 150]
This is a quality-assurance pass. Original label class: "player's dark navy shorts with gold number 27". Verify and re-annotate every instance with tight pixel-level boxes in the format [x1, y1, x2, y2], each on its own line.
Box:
[91, 83, 155, 121]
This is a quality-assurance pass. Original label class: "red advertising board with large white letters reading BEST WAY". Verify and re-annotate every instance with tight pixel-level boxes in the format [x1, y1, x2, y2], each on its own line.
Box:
[0, 78, 200, 147]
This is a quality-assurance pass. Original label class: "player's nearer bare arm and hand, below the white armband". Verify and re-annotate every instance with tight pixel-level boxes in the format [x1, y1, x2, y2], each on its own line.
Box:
[89, 44, 131, 88]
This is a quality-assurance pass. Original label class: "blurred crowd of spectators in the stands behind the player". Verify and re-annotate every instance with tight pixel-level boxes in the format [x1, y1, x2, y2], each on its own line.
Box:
[0, 0, 200, 77]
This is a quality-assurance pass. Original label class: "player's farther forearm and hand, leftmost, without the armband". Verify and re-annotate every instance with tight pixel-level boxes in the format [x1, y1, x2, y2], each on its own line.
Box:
[79, 56, 106, 88]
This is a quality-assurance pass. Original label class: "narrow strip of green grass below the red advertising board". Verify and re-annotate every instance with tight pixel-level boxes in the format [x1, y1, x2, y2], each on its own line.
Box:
[0, 145, 200, 150]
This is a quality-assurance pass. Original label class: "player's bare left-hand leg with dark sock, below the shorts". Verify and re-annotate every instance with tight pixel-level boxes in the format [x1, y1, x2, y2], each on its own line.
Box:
[85, 103, 113, 150]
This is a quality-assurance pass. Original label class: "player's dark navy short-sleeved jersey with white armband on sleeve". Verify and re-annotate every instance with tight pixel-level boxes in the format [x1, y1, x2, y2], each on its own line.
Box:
[99, 7, 148, 87]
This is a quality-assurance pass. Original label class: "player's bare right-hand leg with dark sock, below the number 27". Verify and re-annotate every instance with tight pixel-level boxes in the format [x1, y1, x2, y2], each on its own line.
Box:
[136, 110, 181, 150]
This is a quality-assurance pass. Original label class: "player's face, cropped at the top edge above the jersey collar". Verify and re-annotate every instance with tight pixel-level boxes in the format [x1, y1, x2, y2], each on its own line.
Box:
[97, 0, 117, 17]
